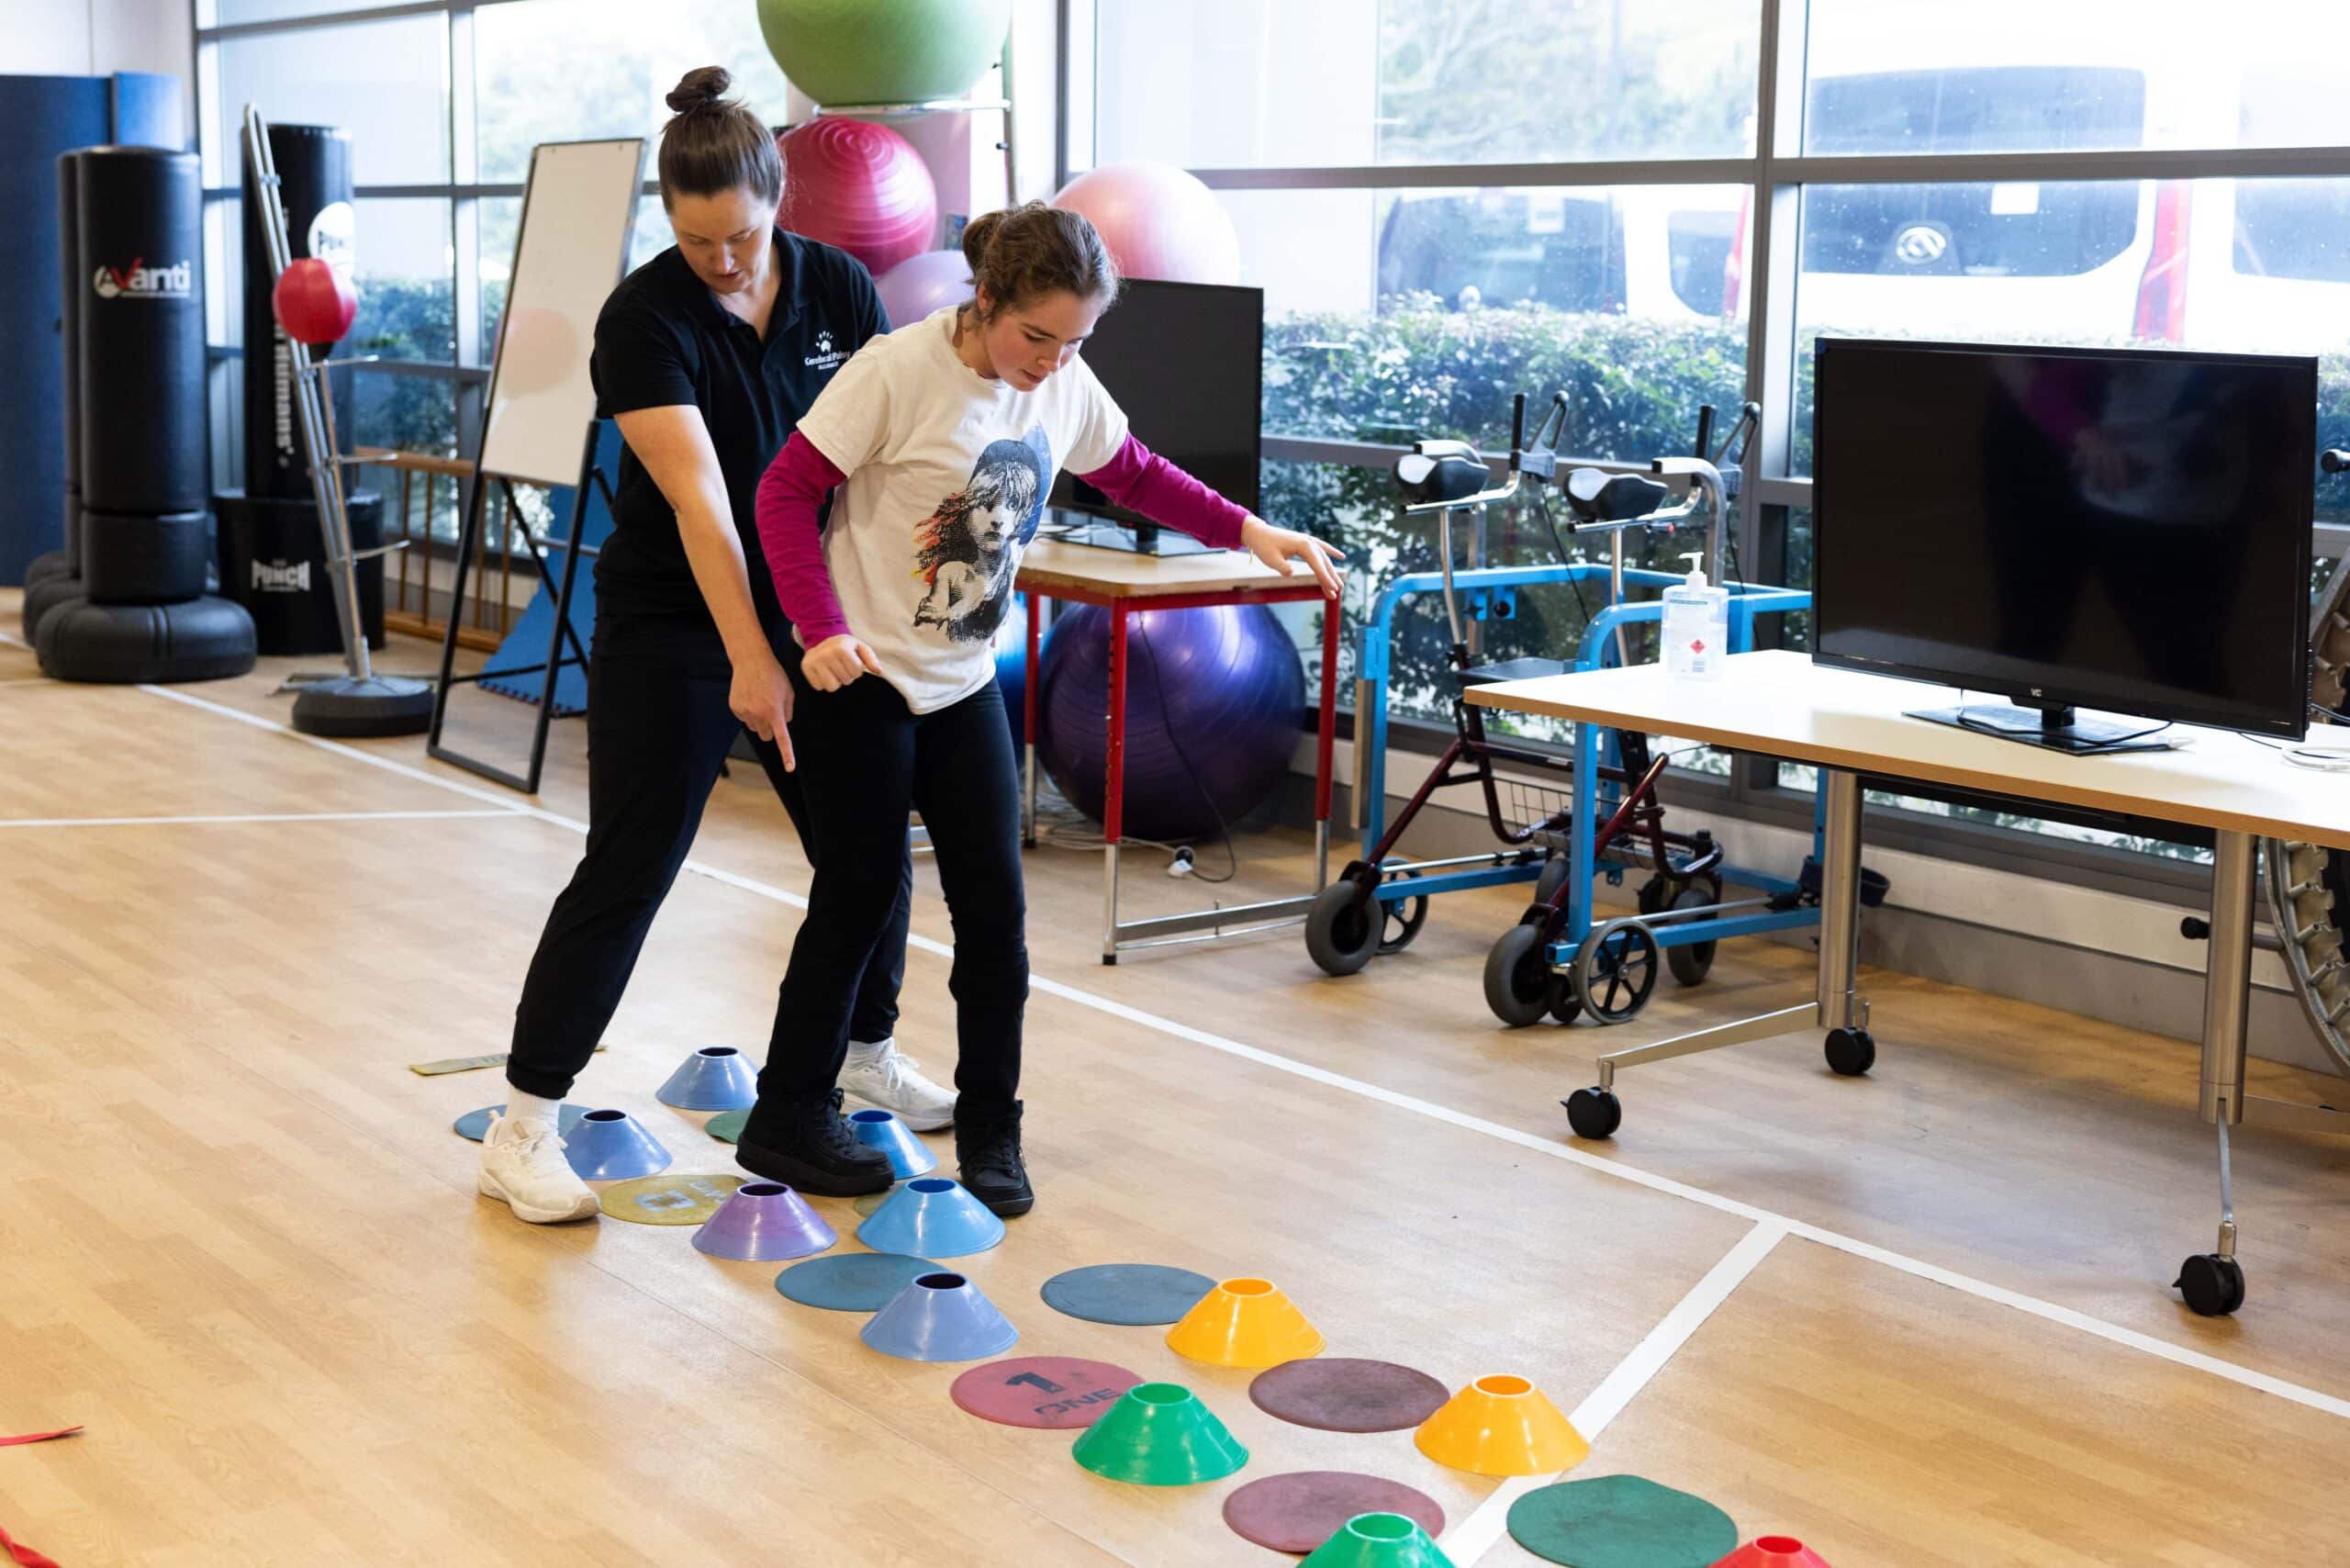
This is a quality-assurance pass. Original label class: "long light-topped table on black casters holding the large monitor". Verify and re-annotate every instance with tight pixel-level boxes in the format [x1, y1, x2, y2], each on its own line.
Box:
[1469, 651, 2350, 1316]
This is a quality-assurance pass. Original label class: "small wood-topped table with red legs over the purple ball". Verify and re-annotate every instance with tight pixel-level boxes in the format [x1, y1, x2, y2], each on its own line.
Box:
[1015, 538, 1339, 964]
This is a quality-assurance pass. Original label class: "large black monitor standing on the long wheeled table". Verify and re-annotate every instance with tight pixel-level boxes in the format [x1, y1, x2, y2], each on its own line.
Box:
[1812, 339, 2317, 750]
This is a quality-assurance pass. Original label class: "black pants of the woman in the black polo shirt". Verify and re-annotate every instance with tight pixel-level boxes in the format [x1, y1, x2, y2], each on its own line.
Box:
[505, 607, 907, 1100]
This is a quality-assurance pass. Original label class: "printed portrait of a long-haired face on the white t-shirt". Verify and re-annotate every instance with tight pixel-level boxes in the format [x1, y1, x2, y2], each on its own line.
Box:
[914, 425, 1053, 642]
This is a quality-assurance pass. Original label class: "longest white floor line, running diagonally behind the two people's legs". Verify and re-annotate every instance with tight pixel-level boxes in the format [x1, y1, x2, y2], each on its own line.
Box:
[110, 687, 2350, 1420]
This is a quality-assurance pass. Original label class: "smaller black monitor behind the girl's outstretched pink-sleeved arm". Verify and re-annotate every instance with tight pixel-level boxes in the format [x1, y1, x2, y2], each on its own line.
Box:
[1050, 277, 1264, 548]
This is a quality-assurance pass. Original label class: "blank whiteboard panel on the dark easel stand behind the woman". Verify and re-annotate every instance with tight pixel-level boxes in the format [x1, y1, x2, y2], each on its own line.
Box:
[482, 137, 643, 485]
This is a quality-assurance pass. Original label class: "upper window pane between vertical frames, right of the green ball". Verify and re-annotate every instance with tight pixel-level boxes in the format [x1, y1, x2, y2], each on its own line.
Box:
[1095, 0, 1760, 169]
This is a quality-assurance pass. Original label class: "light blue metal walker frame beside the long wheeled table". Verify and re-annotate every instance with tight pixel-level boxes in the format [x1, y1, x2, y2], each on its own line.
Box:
[1356, 562, 1826, 991]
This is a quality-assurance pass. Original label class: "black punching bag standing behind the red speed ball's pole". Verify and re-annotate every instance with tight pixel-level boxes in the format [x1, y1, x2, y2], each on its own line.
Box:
[240, 125, 355, 500]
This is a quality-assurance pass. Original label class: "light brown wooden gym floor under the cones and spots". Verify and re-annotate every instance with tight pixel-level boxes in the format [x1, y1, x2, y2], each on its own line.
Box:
[0, 592, 2350, 1568]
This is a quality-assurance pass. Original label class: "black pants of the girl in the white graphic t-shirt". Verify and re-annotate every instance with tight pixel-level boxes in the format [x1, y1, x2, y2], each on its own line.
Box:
[759, 666, 1027, 1116]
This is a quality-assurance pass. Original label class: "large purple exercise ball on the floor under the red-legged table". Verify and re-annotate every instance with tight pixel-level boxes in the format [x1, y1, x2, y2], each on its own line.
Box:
[1036, 604, 1306, 842]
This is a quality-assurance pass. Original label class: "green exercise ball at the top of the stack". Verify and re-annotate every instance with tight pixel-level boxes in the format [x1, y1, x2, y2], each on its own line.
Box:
[759, 0, 1013, 104]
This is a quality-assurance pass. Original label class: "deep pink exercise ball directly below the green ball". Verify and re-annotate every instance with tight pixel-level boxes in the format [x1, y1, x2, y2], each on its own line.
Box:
[776, 115, 937, 277]
